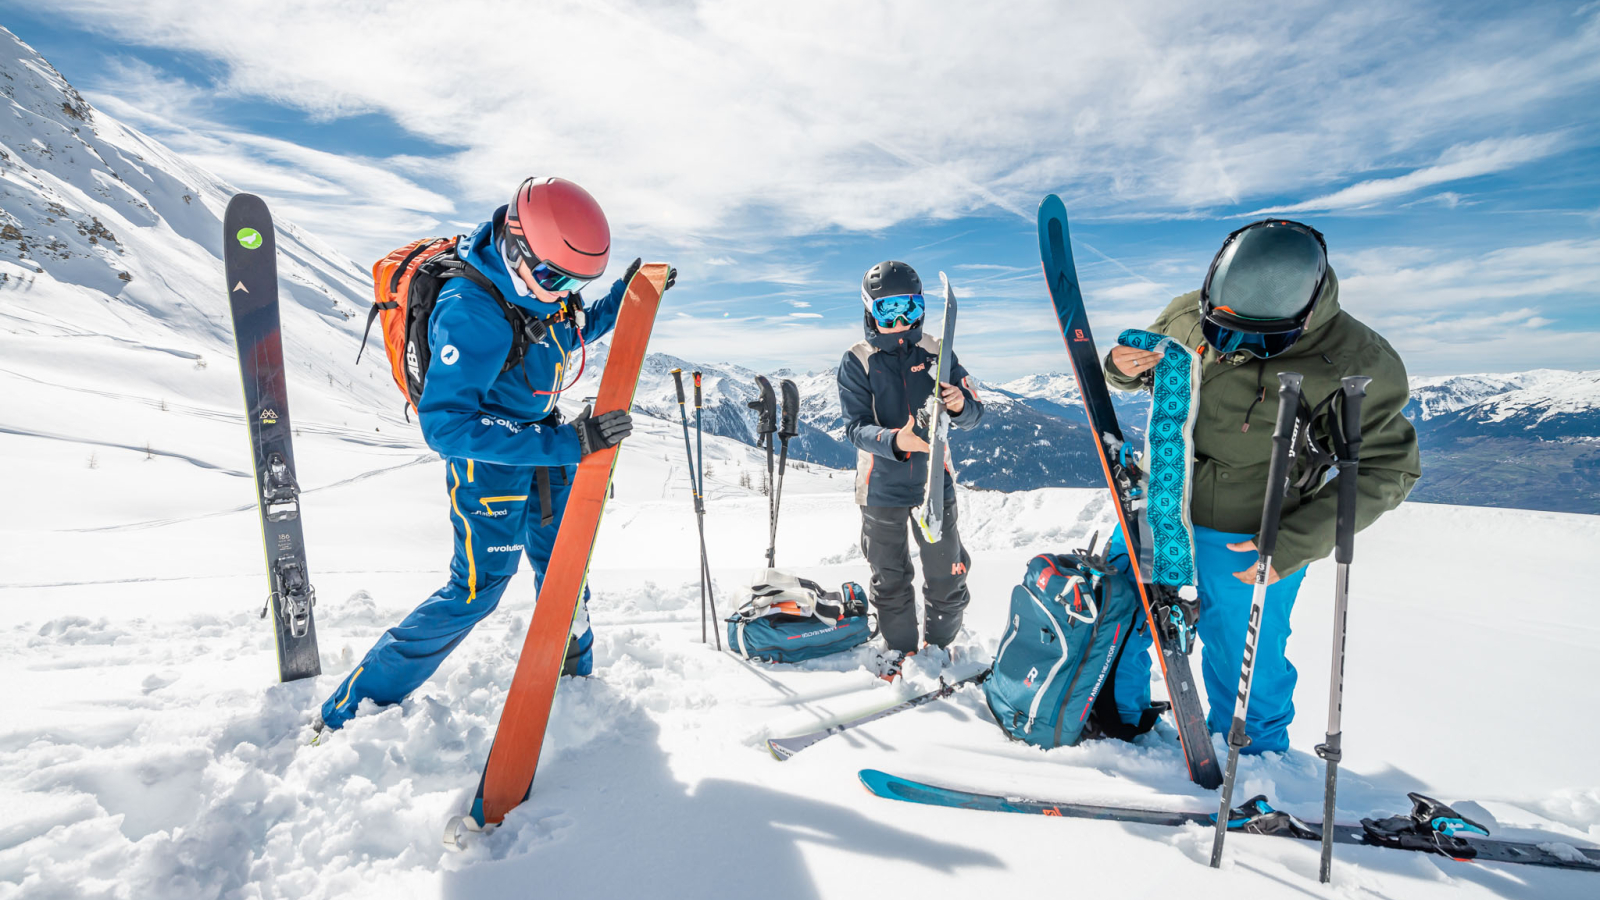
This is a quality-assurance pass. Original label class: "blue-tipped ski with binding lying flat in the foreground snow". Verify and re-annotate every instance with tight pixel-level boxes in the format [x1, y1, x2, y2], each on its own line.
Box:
[859, 769, 1600, 871]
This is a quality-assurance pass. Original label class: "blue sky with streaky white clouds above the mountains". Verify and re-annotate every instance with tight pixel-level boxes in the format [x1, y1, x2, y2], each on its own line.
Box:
[0, 0, 1600, 381]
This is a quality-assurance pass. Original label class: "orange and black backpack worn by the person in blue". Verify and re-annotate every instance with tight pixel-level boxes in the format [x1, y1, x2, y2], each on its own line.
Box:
[355, 237, 544, 410]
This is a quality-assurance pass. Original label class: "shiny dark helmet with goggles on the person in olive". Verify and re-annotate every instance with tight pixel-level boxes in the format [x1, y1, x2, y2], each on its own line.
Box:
[1200, 219, 1328, 357]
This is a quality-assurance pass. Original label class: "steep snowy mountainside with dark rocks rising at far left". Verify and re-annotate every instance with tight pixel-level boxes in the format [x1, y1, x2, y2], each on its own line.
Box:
[0, 23, 400, 450]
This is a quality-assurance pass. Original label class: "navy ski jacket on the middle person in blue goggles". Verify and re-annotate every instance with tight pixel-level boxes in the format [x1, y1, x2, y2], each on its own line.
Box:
[838, 323, 984, 506]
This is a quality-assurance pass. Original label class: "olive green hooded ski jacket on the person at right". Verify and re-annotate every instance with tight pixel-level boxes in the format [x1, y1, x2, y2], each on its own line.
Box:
[1106, 269, 1422, 575]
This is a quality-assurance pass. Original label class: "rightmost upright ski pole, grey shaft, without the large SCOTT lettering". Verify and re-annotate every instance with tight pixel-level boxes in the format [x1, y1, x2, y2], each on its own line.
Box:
[1317, 375, 1371, 884]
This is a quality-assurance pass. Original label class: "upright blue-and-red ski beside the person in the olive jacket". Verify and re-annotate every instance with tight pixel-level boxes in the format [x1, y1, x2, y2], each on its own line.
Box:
[1038, 194, 1222, 790]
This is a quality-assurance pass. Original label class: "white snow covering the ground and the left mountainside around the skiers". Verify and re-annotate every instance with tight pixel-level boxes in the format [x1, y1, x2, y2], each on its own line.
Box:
[0, 24, 1600, 900]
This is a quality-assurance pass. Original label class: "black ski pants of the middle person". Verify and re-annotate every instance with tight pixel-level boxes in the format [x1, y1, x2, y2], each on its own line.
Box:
[861, 498, 973, 653]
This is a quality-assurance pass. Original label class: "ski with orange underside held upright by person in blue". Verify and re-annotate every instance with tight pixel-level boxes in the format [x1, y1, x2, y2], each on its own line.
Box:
[445, 263, 667, 849]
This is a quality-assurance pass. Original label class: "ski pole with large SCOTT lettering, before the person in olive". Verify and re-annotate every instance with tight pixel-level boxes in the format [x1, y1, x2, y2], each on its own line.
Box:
[1211, 372, 1301, 868]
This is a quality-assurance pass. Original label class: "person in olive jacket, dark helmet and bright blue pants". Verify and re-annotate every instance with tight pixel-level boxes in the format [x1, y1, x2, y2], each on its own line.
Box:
[1106, 219, 1421, 753]
